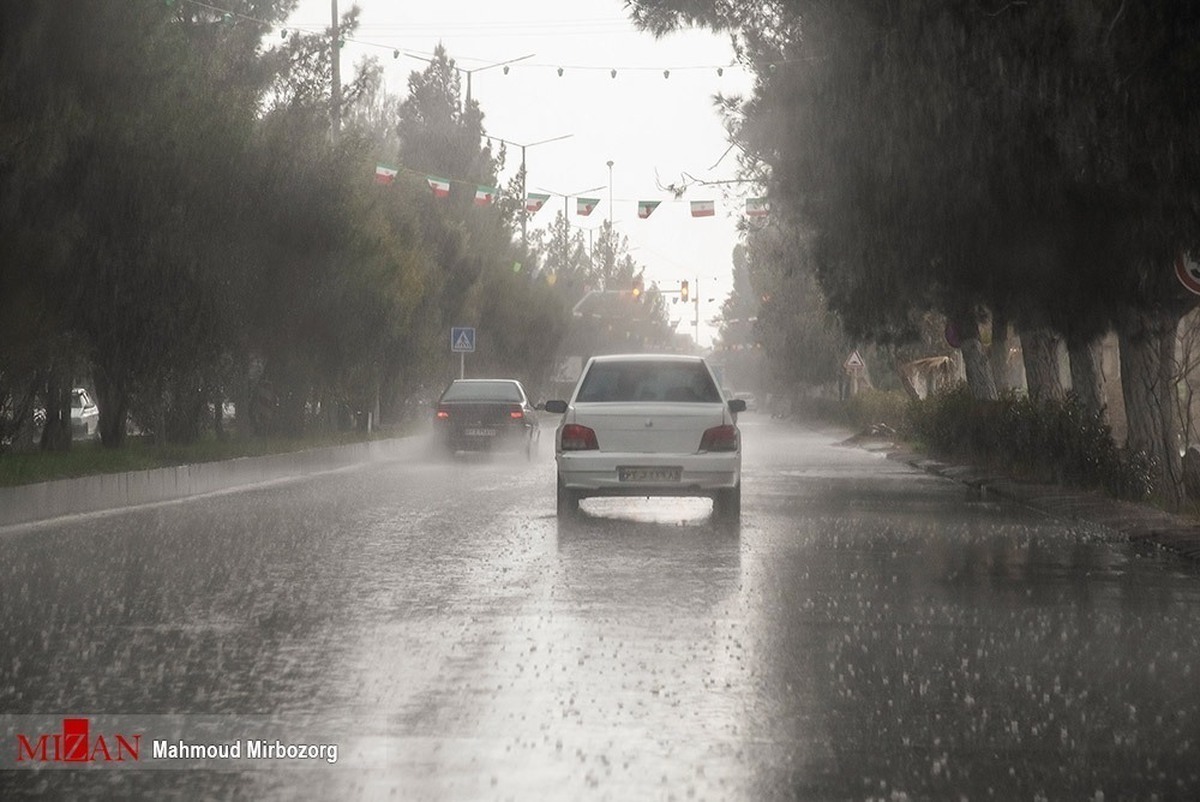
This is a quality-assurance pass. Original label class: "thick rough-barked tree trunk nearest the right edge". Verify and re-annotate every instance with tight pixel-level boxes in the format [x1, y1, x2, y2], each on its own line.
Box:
[1117, 311, 1183, 509]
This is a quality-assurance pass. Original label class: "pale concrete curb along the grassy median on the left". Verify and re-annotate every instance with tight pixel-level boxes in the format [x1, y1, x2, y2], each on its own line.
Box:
[0, 436, 414, 526]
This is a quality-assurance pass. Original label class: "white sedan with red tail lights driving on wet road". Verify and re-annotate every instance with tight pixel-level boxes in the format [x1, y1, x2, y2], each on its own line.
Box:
[545, 354, 745, 517]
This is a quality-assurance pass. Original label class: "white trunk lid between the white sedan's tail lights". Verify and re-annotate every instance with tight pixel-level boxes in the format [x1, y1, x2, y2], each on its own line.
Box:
[575, 403, 724, 454]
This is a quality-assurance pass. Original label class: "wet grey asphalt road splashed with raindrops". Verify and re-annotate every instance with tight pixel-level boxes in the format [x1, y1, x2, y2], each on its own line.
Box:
[0, 414, 1200, 802]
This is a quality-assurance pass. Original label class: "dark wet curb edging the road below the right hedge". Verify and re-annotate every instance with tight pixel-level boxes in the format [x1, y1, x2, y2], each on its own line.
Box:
[887, 444, 1200, 559]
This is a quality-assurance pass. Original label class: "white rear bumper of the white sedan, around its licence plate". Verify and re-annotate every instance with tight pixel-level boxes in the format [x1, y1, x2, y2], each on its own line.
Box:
[558, 451, 742, 496]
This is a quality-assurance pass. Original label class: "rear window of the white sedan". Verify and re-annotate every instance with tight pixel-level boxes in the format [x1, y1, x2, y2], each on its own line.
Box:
[575, 361, 721, 403]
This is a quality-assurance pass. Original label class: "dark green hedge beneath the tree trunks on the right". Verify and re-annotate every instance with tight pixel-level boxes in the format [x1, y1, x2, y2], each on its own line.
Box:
[910, 384, 1156, 501]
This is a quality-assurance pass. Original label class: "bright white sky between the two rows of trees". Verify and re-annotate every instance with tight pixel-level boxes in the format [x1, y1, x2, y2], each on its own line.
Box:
[289, 0, 762, 345]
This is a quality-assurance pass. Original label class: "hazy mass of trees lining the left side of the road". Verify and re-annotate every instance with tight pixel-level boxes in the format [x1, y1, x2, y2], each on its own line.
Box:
[0, 0, 672, 449]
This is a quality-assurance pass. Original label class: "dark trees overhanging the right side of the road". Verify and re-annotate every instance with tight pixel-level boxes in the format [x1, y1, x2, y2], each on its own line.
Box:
[631, 0, 1200, 502]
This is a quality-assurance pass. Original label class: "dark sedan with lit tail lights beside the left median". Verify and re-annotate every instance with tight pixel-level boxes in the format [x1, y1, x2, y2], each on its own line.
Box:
[433, 378, 540, 459]
